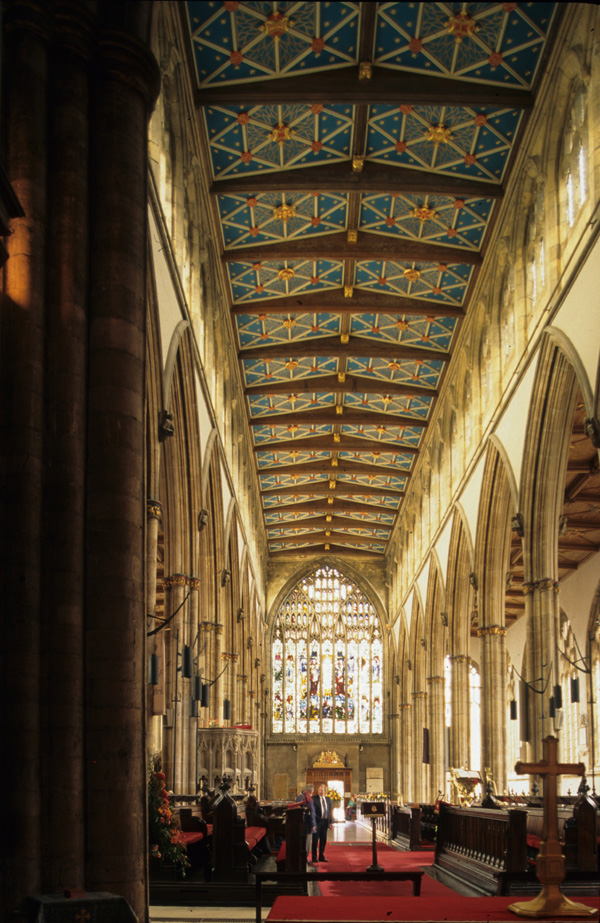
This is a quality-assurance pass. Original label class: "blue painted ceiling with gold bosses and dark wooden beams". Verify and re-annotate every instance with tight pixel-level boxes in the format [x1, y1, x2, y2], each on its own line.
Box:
[185, 0, 557, 558]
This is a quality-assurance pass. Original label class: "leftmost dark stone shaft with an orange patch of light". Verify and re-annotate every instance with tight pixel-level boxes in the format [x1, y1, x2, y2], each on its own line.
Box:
[0, 0, 50, 910]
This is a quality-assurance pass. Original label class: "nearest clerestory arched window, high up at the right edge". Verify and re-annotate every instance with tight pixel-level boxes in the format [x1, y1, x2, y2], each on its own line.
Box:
[561, 84, 588, 228]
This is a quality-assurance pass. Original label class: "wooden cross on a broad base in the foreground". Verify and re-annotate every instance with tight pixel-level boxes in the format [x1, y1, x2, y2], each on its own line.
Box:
[509, 737, 598, 917]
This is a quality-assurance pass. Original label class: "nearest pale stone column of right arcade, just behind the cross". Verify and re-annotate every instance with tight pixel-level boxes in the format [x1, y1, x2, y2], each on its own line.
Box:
[523, 577, 559, 760]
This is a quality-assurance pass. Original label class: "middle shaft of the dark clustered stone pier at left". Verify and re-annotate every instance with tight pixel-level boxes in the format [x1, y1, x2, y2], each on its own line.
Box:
[42, 2, 93, 893]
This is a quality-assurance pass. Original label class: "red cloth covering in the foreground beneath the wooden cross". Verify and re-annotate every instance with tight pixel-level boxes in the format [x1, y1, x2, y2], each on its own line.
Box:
[266, 896, 598, 923]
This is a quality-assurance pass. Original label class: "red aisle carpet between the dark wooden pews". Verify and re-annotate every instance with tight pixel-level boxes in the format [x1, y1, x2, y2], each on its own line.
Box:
[318, 843, 454, 898]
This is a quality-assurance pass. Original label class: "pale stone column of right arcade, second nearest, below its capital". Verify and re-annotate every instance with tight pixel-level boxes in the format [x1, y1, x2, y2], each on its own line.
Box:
[477, 625, 506, 796]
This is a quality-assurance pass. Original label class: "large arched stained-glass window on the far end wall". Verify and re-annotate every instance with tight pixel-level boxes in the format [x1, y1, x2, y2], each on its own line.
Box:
[272, 565, 383, 734]
